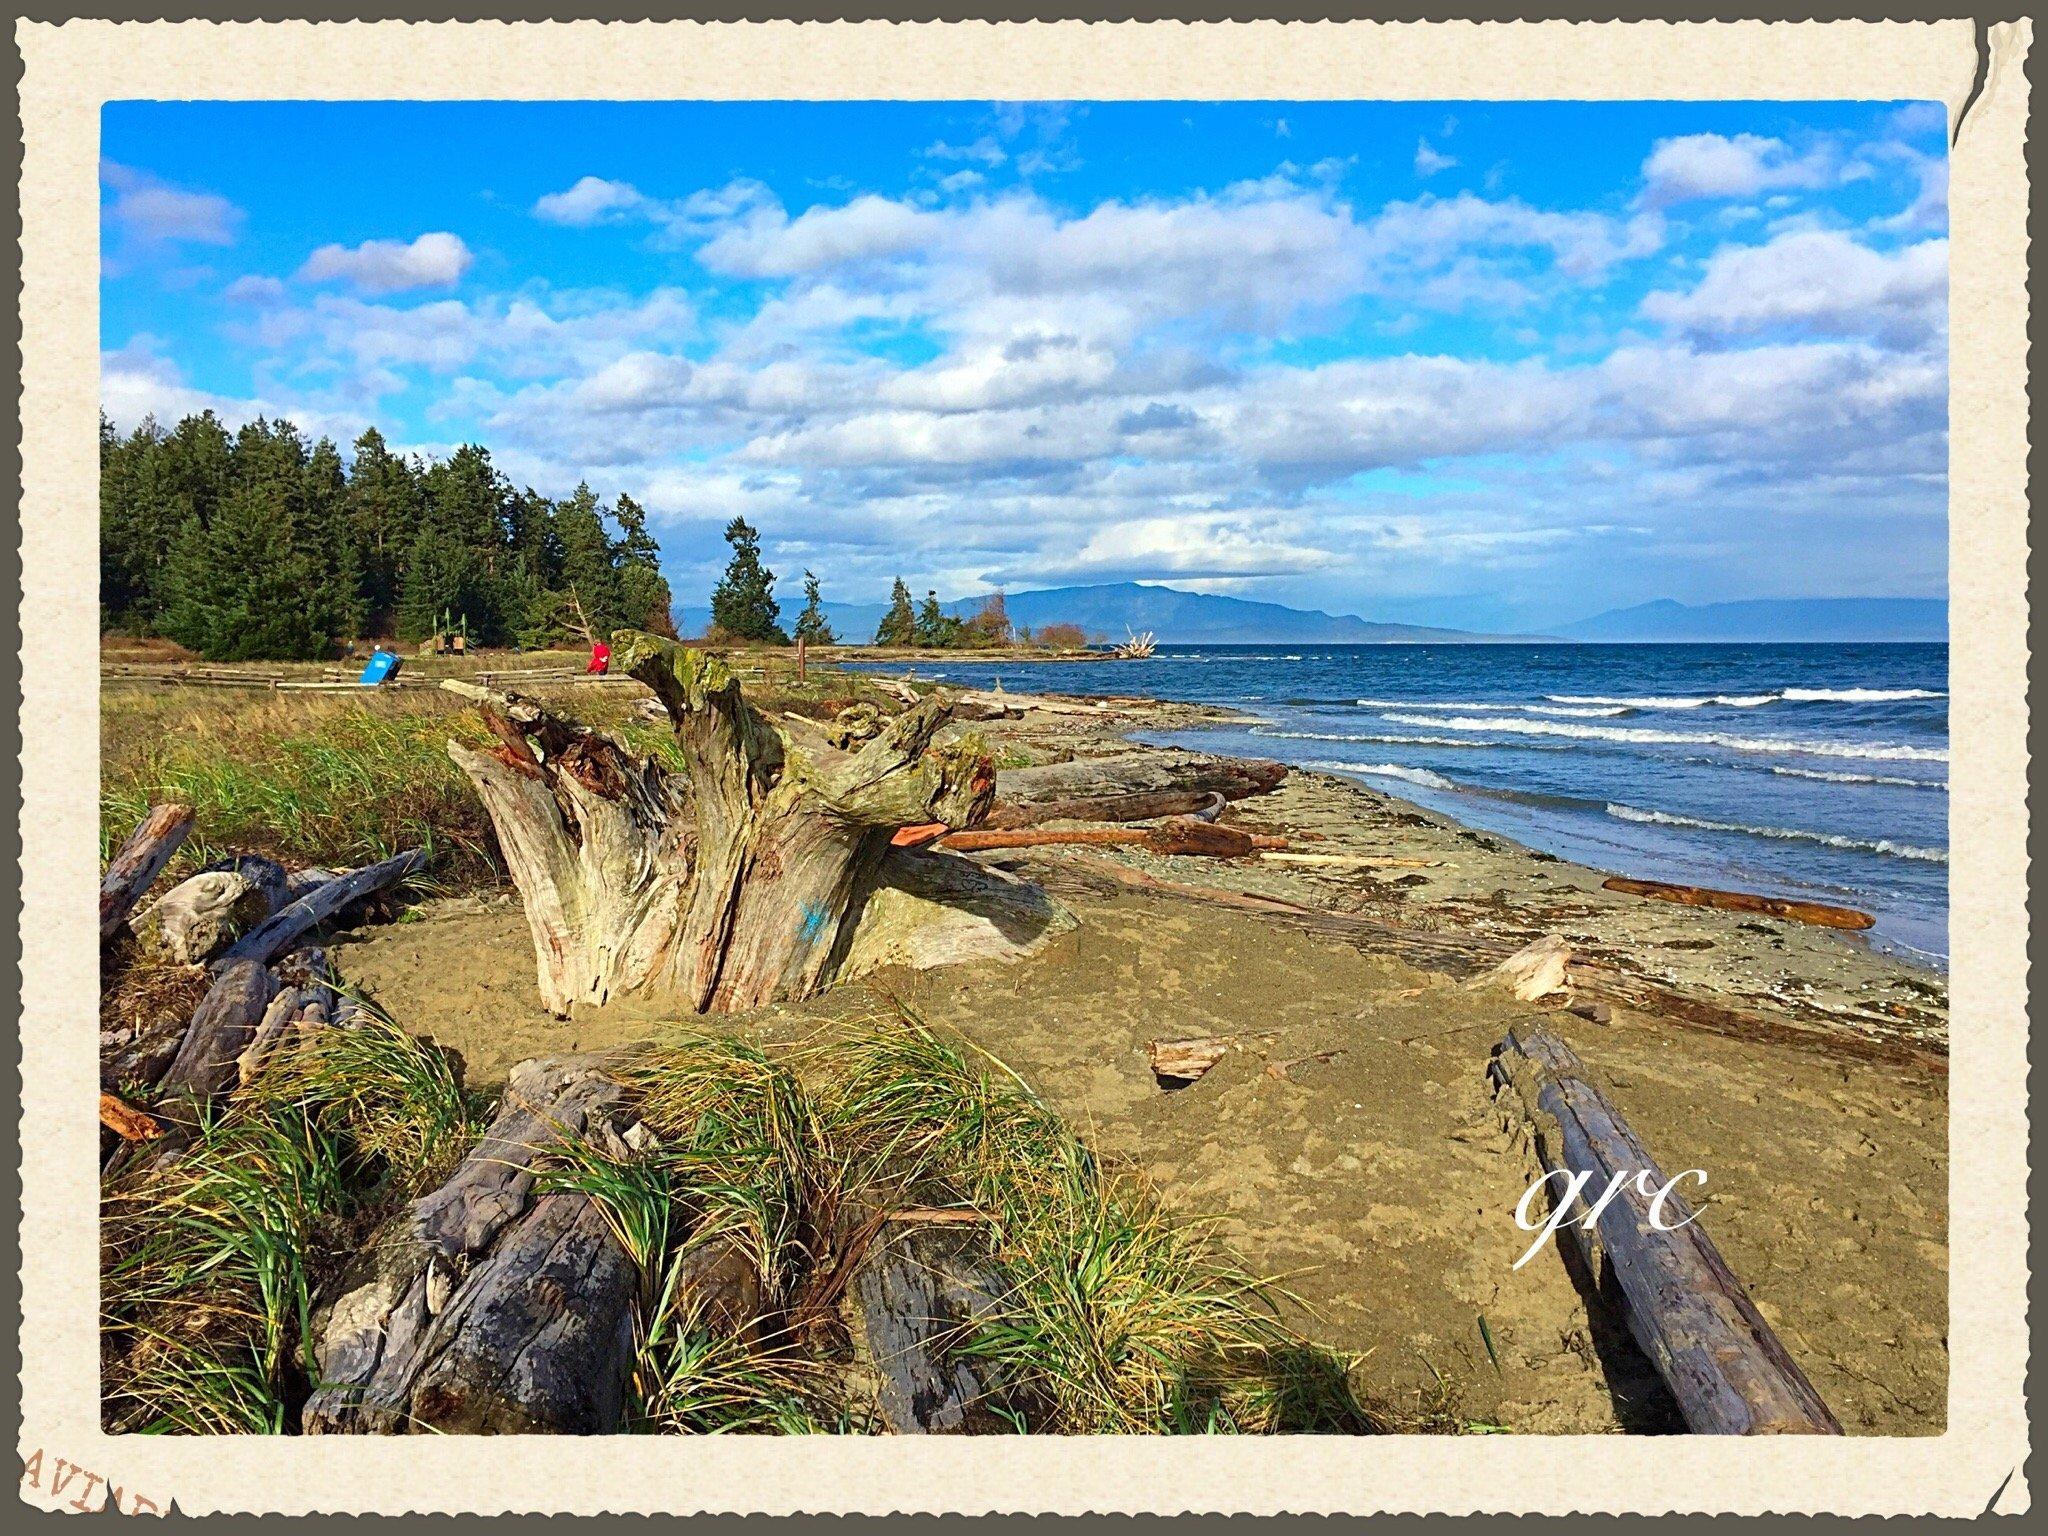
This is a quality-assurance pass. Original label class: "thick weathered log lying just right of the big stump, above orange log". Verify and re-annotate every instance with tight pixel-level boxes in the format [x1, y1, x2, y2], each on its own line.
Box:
[985, 752, 1286, 829]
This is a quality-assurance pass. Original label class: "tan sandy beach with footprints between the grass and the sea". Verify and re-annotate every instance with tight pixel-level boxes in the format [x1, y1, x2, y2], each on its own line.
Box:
[336, 679, 1948, 1434]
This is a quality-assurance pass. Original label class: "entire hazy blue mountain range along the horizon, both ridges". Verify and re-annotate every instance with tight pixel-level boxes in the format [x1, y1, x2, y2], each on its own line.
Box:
[802, 582, 1948, 645]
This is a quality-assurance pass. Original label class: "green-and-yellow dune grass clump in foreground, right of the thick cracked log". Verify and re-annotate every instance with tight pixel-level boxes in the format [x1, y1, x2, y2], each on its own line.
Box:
[547, 1018, 1380, 1434]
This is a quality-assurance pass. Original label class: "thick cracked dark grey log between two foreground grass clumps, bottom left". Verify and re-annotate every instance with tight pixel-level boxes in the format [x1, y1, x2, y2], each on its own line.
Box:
[303, 1057, 639, 1434]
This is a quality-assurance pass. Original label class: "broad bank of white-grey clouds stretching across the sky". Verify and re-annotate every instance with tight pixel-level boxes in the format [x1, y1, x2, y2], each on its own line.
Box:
[136, 135, 1946, 618]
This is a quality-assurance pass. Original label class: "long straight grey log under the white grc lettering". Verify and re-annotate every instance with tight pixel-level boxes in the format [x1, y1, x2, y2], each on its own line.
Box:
[1489, 1026, 1841, 1436]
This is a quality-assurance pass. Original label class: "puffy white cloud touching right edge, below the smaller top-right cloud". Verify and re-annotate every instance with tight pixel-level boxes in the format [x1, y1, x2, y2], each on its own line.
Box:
[1642, 229, 1948, 340]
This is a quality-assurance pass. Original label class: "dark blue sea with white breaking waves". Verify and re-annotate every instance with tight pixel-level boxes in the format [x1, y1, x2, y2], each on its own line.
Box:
[851, 645, 1948, 965]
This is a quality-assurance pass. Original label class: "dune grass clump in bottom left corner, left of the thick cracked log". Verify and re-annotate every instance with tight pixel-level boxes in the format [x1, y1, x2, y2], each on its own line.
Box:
[100, 1014, 481, 1434]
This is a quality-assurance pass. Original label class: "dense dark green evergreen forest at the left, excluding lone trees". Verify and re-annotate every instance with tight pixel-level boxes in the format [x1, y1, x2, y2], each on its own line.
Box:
[100, 412, 674, 662]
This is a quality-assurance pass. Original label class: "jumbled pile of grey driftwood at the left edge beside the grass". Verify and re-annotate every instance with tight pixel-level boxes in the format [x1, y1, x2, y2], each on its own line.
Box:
[100, 805, 426, 1169]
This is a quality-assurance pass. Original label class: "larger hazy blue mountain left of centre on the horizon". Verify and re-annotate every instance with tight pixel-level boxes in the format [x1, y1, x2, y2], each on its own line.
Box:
[819, 582, 1528, 645]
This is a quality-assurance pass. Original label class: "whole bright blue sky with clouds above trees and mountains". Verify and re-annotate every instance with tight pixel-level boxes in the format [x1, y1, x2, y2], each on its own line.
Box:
[100, 102, 1948, 629]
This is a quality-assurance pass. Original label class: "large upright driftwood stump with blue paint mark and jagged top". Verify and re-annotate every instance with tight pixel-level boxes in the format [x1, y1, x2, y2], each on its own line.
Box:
[449, 631, 995, 1016]
